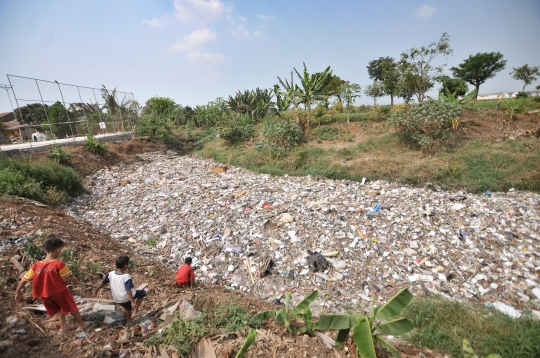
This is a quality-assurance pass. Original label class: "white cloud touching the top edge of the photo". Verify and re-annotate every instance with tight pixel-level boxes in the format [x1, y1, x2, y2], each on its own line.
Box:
[174, 0, 231, 24]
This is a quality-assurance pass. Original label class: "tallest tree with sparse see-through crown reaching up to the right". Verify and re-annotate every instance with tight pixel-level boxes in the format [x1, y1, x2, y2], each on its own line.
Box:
[399, 32, 454, 102]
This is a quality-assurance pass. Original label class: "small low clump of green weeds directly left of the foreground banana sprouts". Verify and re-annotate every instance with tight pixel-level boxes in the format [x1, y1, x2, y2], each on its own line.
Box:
[209, 303, 262, 333]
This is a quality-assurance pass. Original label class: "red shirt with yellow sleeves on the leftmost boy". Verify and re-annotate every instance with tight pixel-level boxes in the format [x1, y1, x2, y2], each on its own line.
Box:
[22, 260, 72, 298]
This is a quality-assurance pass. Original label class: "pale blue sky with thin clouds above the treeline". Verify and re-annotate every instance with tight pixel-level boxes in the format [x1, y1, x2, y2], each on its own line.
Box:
[0, 0, 540, 106]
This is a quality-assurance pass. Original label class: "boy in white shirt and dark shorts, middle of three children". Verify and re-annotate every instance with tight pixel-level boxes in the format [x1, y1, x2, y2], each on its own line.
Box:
[93, 256, 146, 324]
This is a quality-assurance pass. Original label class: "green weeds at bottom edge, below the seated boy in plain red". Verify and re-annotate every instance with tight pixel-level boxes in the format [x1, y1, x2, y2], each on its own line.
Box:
[144, 312, 208, 356]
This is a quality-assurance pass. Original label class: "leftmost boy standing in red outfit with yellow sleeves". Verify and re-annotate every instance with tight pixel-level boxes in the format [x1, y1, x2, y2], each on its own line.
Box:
[15, 237, 92, 334]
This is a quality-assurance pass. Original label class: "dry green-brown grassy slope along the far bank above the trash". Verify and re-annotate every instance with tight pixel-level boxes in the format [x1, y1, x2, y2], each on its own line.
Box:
[198, 133, 540, 193]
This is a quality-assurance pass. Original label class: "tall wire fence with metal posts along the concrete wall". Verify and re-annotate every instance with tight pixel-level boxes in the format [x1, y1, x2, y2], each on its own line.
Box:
[0, 75, 138, 147]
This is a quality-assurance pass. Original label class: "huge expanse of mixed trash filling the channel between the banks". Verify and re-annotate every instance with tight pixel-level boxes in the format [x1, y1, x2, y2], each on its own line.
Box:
[66, 153, 540, 314]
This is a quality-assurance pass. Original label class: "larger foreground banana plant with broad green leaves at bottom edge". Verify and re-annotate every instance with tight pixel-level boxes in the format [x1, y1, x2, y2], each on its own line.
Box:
[318, 289, 414, 358]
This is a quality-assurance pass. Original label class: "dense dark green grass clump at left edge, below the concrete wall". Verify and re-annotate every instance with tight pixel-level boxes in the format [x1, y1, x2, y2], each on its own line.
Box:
[0, 156, 85, 205]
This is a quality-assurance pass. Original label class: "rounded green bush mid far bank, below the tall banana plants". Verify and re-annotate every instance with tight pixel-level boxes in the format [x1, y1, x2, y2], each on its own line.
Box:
[255, 118, 304, 156]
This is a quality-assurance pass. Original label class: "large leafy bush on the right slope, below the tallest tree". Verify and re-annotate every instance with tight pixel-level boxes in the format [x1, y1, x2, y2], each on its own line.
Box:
[388, 100, 463, 151]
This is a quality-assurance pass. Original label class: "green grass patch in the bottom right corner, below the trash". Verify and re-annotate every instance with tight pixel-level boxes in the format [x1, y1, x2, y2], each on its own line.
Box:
[404, 299, 540, 358]
